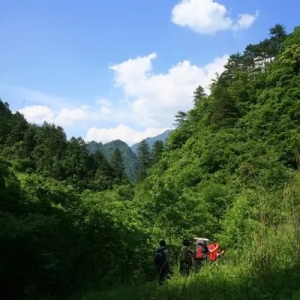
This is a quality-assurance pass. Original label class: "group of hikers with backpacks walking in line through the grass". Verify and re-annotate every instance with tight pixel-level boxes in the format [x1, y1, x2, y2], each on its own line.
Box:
[153, 238, 224, 284]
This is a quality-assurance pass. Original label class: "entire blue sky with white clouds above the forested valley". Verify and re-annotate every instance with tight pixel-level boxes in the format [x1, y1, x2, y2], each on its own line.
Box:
[0, 0, 300, 145]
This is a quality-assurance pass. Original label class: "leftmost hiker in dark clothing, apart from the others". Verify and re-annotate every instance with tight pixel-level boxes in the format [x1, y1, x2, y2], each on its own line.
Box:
[153, 240, 171, 285]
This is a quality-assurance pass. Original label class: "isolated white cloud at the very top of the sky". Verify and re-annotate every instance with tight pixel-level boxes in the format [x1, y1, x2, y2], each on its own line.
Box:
[171, 0, 258, 34]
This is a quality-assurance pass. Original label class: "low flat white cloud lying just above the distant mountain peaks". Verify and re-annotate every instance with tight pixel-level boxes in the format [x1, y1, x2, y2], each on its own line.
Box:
[85, 124, 169, 146]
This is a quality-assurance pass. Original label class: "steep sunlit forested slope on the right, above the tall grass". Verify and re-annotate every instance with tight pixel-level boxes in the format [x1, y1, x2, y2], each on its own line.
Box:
[132, 25, 300, 245]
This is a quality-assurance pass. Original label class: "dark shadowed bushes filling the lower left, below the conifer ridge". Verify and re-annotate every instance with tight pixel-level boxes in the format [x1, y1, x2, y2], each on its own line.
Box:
[0, 160, 147, 299]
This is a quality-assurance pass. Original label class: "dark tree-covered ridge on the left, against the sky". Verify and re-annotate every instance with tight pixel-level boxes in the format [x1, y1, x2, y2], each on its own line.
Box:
[0, 110, 120, 191]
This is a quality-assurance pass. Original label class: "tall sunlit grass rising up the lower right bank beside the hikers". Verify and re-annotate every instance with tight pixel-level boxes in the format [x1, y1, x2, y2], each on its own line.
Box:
[79, 181, 300, 300]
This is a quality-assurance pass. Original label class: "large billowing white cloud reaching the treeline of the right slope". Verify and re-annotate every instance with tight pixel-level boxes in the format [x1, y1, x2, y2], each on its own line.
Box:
[110, 53, 228, 128]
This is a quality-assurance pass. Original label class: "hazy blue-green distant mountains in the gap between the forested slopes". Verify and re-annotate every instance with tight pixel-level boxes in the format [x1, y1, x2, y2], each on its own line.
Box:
[86, 130, 172, 181]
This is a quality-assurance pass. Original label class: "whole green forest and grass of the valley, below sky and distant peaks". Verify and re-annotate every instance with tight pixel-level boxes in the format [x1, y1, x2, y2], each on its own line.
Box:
[0, 24, 300, 300]
